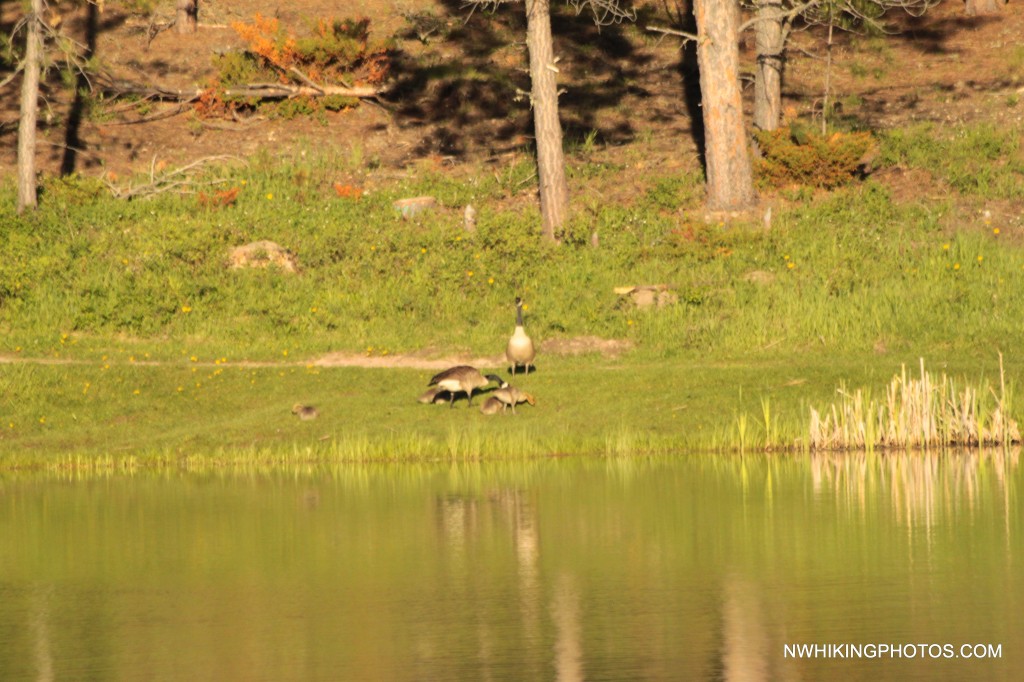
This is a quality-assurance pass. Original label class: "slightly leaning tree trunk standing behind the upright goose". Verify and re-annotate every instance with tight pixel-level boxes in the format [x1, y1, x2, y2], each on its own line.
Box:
[524, 0, 569, 242]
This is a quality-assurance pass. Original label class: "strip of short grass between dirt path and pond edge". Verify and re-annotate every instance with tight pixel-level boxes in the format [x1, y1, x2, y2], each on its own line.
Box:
[0, 346, 1024, 471]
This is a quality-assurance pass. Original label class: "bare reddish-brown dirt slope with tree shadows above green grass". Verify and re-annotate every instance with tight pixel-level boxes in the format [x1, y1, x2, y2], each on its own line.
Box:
[0, 0, 1024, 187]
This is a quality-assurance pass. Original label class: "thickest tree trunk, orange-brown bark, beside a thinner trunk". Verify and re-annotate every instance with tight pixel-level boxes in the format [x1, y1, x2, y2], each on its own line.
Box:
[693, 0, 757, 211]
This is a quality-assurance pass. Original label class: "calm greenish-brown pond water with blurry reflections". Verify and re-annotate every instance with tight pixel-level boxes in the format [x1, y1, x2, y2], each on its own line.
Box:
[0, 454, 1024, 682]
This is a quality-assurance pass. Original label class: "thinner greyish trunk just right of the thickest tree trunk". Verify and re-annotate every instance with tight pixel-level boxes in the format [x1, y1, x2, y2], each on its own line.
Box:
[754, 0, 785, 130]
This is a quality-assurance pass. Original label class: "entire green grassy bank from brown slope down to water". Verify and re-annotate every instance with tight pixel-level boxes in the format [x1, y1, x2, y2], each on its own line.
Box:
[0, 120, 1024, 461]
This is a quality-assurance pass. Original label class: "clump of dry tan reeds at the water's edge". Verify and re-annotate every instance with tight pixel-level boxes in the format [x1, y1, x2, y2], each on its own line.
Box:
[809, 354, 1021, 450]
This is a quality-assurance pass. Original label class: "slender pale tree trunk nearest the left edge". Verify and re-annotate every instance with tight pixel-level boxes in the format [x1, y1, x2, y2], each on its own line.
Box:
[17, 0, 43, 213]
